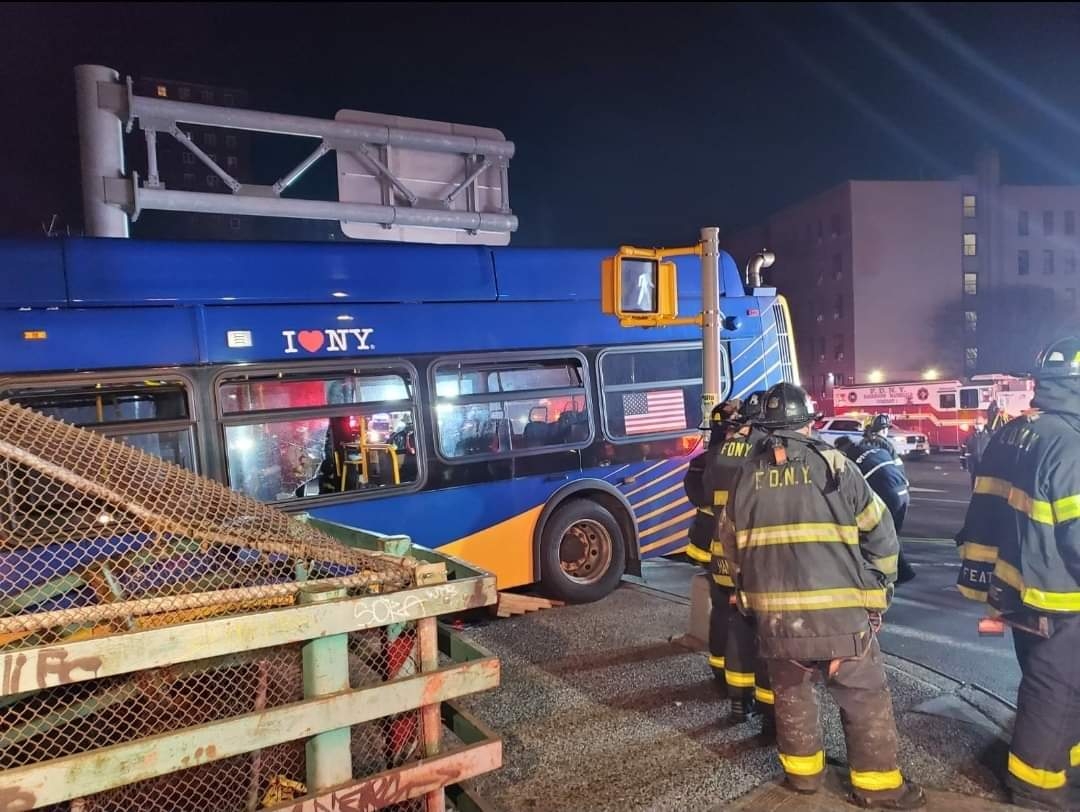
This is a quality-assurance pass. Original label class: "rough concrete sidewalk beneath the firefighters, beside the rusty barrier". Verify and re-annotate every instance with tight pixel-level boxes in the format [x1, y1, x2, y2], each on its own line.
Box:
[457, 584, 1010, 812]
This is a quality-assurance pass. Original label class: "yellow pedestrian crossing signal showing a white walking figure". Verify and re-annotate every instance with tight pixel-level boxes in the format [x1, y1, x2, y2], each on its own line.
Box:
[600, 245, 678, 327]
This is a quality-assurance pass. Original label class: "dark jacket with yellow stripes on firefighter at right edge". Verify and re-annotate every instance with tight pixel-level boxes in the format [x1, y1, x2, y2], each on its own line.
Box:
[957, 412, 1080, 613]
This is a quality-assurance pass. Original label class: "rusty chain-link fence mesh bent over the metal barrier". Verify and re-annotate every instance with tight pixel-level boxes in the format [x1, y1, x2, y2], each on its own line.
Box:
[0, 403, 442, 812]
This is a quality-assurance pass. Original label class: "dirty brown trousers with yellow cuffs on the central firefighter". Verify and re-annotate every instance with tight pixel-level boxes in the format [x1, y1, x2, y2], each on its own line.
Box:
[769, 637, 904, 800]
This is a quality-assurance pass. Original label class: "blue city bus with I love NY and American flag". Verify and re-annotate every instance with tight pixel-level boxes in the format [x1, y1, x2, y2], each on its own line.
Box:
[0, 239, 798, 601]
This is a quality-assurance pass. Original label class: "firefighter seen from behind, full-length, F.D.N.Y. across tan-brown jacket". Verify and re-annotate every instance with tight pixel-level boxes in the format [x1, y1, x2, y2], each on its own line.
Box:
[720, 383, 926, 809]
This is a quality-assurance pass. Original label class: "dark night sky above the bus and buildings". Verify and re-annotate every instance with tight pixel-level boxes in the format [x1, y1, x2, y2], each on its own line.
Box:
[0, 3, 1080, 245]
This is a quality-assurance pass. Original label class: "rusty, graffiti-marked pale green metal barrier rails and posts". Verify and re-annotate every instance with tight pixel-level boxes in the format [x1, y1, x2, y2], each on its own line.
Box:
[0, 519, 502, 812]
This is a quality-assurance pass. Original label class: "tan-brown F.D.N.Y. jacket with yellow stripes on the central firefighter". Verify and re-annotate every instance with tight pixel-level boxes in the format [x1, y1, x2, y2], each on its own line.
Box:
[720, 431, 900, 661]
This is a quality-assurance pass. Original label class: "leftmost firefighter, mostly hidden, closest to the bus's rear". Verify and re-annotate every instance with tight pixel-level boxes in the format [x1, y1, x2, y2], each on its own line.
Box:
[683, 400, 741, 684]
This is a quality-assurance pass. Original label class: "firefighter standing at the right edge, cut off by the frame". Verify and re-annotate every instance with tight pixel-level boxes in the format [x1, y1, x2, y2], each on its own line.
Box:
[957, 337, 1080, 809]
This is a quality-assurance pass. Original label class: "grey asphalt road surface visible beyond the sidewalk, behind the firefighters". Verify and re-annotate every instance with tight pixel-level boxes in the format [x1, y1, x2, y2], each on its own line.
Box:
[643, 455, 1020, 703]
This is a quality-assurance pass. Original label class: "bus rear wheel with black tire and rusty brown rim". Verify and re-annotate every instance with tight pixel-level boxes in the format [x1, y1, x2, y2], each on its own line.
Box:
[540, 499, 626, 604]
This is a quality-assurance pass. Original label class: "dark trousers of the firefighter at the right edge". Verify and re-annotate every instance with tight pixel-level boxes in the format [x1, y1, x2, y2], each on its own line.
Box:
[1007, 614, 1080, 809]
